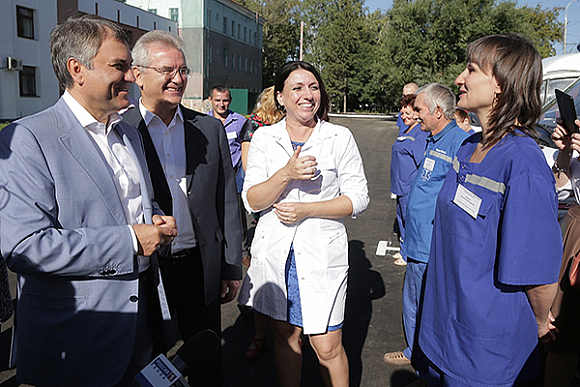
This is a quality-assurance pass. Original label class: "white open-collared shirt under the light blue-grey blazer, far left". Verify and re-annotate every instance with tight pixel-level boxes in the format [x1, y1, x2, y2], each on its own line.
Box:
[63, 91, 150, 272]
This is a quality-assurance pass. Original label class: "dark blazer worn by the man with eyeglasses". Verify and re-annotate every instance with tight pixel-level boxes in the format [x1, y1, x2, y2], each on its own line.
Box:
[123, 106, 242, 304]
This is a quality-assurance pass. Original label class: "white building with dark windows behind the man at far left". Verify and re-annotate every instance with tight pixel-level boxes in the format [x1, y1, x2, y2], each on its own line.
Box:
[0, 0, 178, 122]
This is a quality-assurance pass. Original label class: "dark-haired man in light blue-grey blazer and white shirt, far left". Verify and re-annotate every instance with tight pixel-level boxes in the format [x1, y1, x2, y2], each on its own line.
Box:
[0, 15, 177, 387]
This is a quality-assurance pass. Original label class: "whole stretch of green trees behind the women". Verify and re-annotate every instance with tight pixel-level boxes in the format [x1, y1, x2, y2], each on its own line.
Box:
[248, 0, 563, 111]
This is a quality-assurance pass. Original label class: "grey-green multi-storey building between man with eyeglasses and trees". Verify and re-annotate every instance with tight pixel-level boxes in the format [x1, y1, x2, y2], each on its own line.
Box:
[127, 0, 264, 110]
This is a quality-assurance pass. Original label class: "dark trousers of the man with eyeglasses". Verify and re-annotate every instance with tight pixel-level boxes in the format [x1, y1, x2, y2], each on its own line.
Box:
[161, 247, 223, 387]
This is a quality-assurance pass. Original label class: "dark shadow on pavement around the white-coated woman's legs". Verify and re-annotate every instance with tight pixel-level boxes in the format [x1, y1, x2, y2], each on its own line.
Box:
[222, 240, 382, 387]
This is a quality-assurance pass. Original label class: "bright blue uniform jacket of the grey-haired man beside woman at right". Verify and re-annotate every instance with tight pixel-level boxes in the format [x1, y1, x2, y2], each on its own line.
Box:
[401, 120, 467, 262]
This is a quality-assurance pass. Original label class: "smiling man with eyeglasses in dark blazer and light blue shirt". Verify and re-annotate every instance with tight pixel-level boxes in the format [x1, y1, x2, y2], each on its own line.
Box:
[123, 31, 242, 386]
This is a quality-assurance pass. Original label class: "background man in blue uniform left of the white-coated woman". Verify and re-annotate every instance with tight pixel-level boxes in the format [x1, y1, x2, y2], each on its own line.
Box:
[208, 85, 250, 258]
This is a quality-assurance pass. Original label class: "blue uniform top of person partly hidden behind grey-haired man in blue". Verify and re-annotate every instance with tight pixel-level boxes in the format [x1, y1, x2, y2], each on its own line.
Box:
[391, 124, 429, 196]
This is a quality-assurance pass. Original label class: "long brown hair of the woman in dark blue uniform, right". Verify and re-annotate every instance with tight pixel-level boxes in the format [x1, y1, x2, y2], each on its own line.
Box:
[467, 34, 542, 146]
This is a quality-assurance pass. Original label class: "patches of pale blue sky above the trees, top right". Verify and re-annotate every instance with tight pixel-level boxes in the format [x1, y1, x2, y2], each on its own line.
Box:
[365, 0, 580, 55]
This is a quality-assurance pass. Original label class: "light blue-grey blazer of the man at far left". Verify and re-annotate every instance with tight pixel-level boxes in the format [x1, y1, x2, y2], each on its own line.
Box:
[0, 99, 170, 387]
